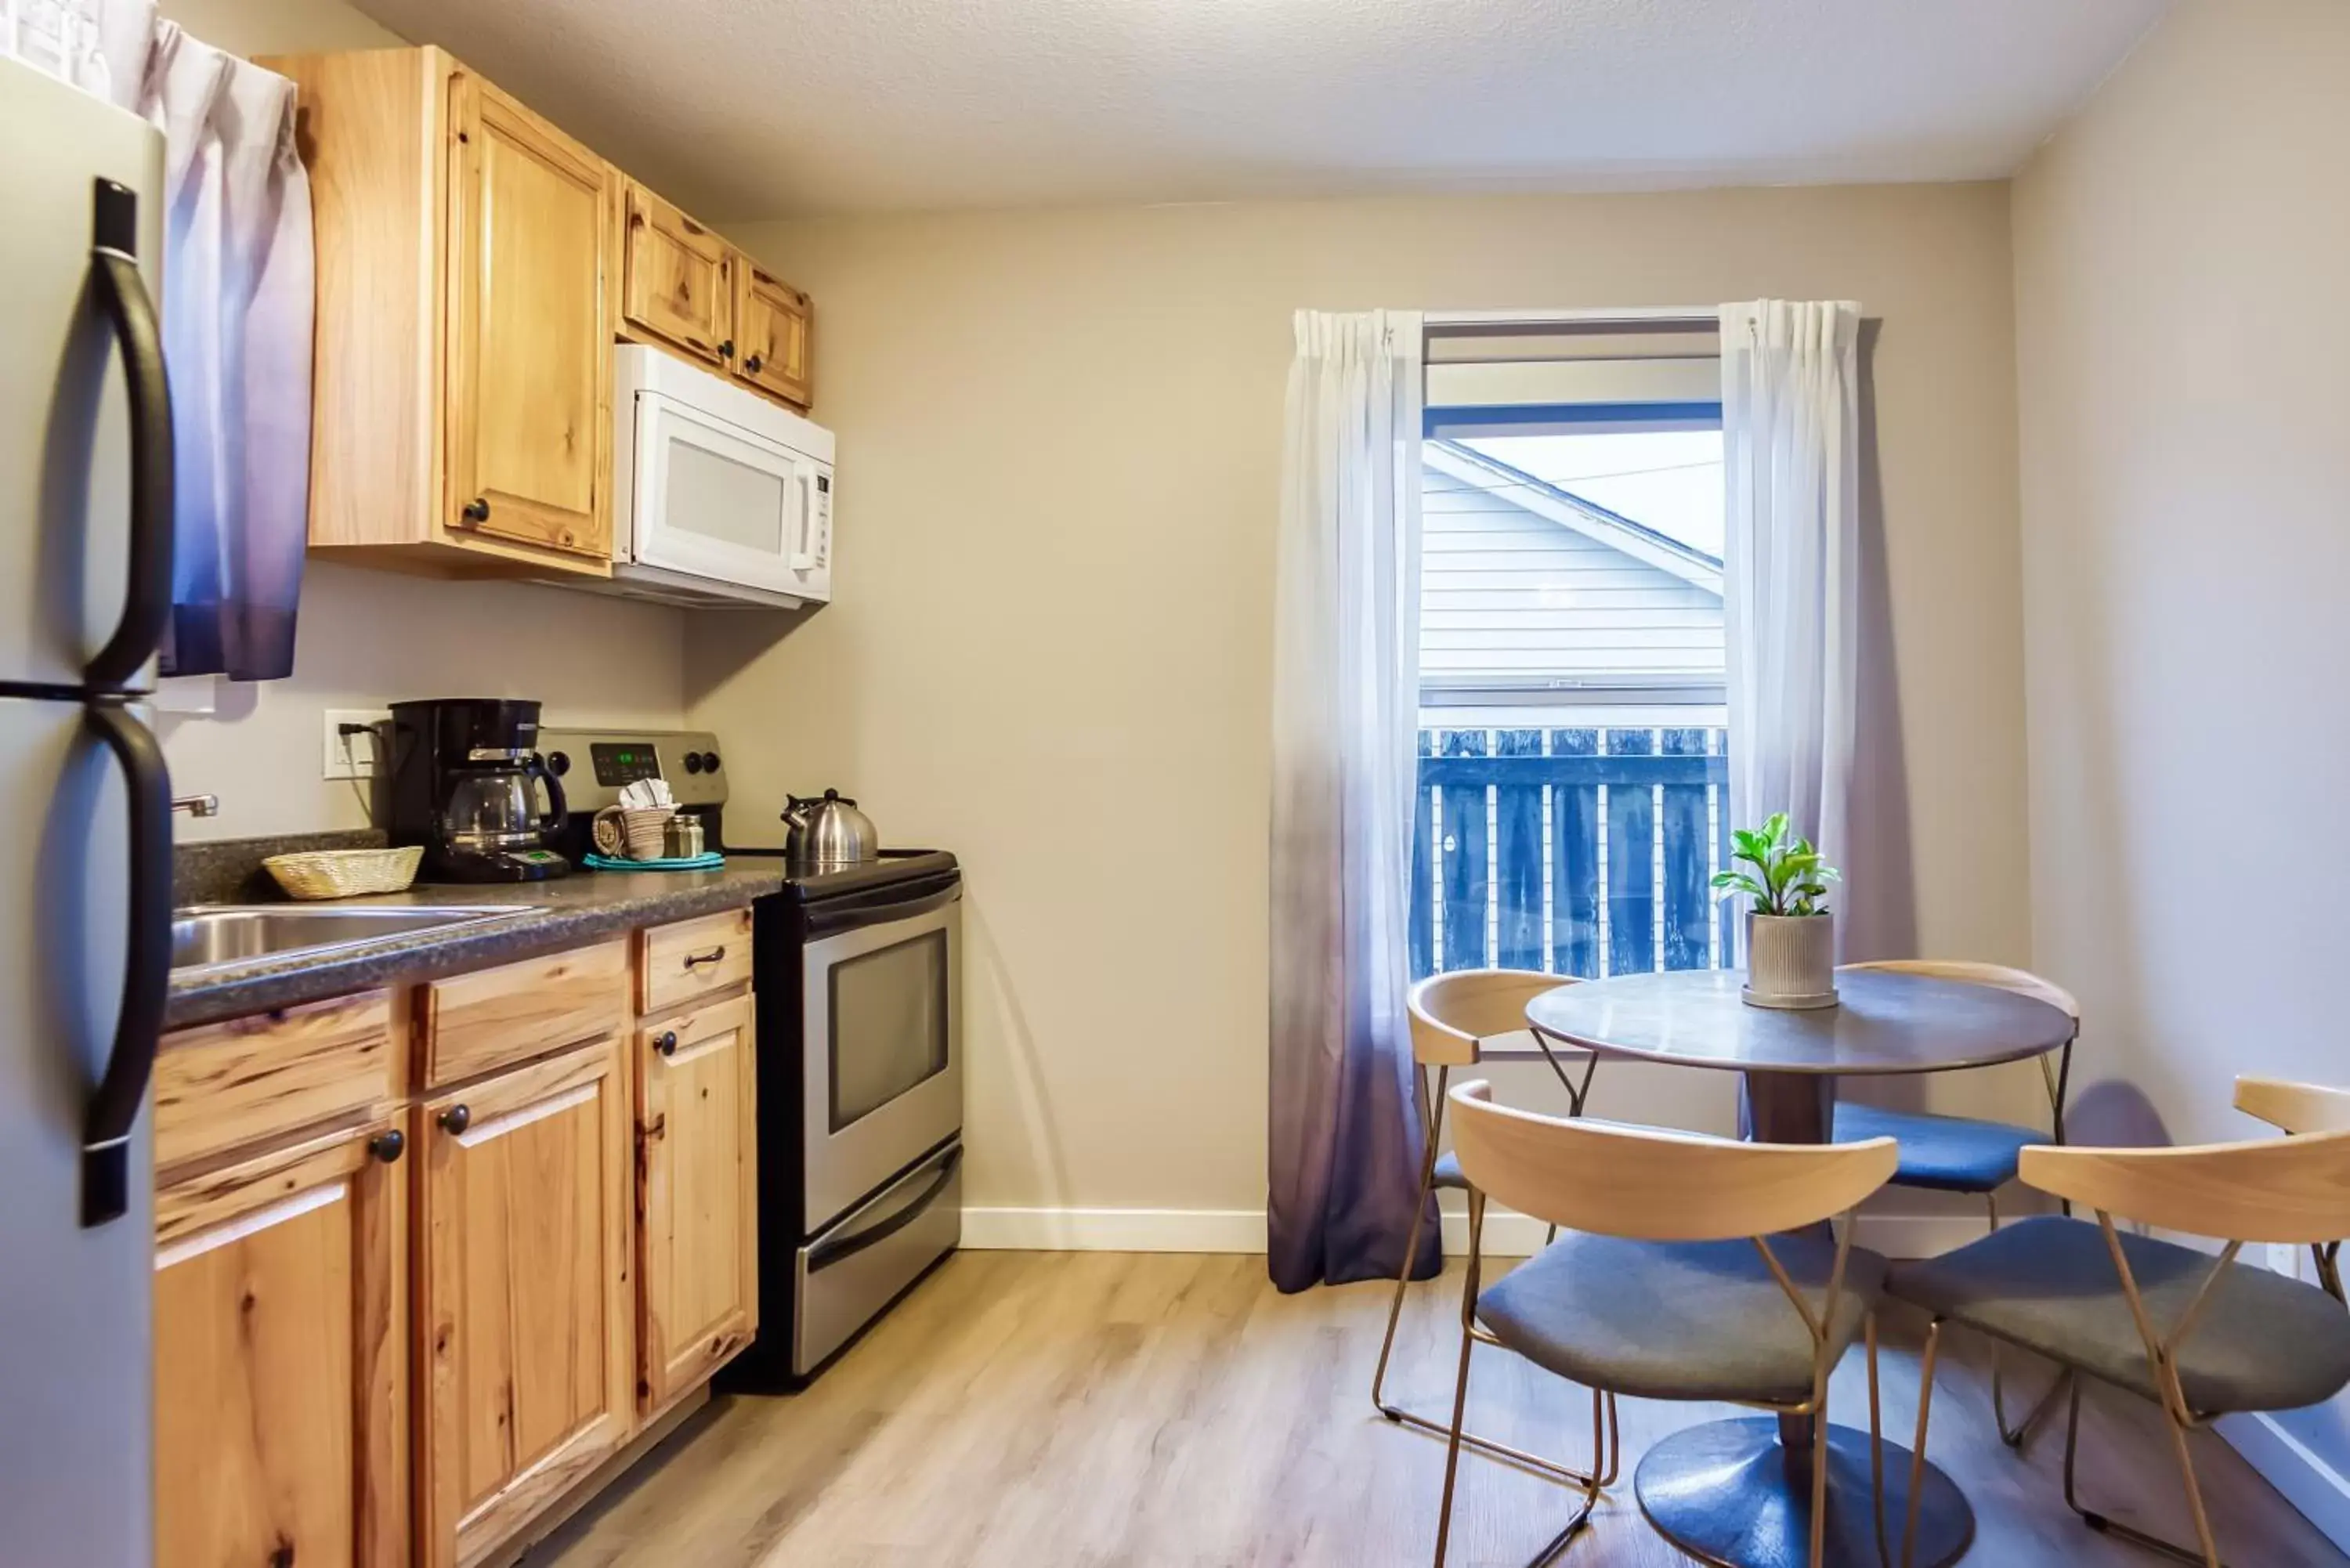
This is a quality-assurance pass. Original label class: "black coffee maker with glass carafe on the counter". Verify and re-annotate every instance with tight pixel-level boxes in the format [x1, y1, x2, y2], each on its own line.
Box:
[388, 695, 571, 882]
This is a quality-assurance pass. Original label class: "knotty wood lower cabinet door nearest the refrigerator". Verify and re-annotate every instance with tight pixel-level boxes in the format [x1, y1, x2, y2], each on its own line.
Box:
[155, 1122, 409, 1568]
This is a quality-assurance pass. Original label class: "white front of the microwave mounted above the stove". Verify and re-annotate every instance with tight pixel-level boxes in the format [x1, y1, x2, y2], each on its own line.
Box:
[630, 392, 832, 599]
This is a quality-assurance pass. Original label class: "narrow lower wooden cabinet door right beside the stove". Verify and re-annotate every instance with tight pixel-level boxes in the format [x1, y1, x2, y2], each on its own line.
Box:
[637, 997, 759, 1413]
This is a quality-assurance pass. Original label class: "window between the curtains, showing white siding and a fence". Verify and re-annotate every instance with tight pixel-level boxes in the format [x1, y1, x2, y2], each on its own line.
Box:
[1410, 322, 1730, 978]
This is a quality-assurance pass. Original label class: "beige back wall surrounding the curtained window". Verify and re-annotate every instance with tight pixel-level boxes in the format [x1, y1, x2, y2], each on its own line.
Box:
[686, 186, 2030, 1211]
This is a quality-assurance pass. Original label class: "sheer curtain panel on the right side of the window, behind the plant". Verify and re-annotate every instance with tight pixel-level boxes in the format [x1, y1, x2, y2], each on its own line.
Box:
[1723, 298, 1861, 941]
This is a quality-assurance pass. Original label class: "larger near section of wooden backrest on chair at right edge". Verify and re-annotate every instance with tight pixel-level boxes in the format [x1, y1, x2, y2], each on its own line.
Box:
[2021, 1131, 2350, 1246]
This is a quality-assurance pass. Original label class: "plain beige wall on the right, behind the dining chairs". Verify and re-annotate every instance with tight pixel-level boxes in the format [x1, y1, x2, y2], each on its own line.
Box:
[2014, 0, 2350, 1140]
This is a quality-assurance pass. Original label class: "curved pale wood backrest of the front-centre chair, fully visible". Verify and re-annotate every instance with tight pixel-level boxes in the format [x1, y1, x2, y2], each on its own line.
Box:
[1450, 1082, 1901, 1241]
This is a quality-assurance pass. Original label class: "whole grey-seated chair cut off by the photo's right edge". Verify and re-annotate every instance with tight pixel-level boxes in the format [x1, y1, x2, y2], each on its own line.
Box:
[1885, 1079, 2350, 1568]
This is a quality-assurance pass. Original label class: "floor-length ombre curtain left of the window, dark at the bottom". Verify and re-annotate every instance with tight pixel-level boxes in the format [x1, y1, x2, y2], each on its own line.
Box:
[1267, 310, 1436, 1291]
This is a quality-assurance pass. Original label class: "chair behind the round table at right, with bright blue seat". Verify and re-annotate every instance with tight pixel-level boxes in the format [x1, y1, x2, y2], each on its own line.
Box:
[1833, 959, 2080, 1448]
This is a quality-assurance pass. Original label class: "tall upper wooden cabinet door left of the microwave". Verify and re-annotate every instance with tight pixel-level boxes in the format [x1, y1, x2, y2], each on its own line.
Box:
[442, 70, 611, 557]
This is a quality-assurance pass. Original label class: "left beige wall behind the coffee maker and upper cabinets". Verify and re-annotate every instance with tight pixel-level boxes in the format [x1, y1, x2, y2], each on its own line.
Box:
[160, 0, 684, 840]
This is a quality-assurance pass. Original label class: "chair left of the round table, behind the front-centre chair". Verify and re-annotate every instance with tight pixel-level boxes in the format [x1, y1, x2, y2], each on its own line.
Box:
[1370, 969, 1622, 1486]
